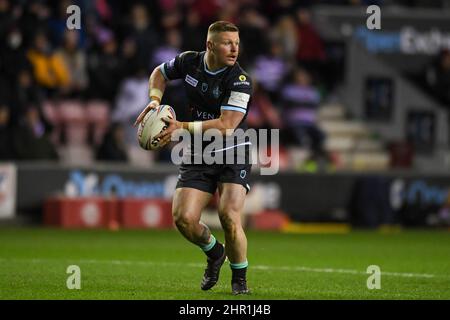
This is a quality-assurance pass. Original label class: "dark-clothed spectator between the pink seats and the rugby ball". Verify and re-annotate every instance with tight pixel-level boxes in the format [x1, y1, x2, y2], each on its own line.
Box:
[96, 122, 128, 162]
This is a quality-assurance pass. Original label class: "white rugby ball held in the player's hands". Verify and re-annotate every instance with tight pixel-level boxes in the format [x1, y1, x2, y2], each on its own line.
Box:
[137, 104, 176, 150]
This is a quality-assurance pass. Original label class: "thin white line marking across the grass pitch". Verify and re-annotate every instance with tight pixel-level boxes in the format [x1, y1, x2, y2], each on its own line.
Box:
[0, 258, 442, 278]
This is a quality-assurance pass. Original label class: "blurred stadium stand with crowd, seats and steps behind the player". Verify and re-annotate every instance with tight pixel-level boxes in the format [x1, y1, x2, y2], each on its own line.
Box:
[0, 0, 450, 230]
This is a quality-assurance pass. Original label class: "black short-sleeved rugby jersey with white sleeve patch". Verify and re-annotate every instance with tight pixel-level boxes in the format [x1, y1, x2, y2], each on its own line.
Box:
[160, 51, 252, 129]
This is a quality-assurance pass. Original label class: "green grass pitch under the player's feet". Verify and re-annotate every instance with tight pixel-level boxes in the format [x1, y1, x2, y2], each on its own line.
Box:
[0, 228, 450, 300]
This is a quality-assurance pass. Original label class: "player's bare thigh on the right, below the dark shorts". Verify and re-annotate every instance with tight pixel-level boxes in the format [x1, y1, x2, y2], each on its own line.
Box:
[219, 183, 247, 222]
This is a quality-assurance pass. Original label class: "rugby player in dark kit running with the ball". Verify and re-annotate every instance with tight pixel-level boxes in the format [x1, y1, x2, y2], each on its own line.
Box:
[135, 21, 252, 295]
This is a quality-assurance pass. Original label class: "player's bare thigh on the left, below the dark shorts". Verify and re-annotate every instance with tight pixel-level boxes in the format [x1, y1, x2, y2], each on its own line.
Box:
[172, 188, 212, 221]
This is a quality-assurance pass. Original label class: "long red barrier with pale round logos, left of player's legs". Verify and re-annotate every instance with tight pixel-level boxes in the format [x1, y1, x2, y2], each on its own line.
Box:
[44, 197, 173, 230]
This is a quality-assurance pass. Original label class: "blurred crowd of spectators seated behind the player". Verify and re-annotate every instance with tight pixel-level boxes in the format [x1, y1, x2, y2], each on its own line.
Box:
[0, 0, 442, 165]
